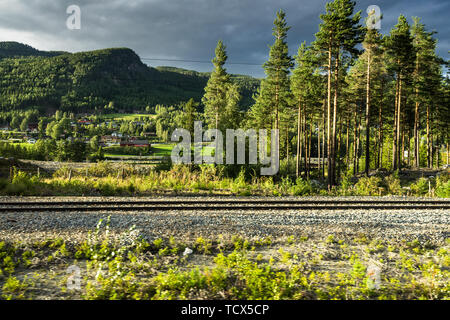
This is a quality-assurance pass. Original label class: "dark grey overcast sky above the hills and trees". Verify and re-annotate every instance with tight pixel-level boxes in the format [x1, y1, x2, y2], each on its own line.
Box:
[0, 0, 450, 77]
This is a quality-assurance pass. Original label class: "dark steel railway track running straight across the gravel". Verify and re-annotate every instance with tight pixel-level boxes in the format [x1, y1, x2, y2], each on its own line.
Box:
[0, 199, 450, 213]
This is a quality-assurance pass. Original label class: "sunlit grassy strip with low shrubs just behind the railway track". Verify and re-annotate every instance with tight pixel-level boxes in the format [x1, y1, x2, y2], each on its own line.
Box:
[0, 162, 450, 198]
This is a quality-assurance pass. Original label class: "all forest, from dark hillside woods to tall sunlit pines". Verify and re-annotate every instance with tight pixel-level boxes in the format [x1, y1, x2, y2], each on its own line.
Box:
[0, 0, 450, 192]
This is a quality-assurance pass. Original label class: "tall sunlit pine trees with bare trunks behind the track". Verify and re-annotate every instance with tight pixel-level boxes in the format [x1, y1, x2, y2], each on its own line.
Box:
[195, 0, 450, 188]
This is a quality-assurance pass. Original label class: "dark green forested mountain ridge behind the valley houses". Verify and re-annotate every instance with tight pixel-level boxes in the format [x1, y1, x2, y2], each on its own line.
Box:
[0, 42, 259, 112]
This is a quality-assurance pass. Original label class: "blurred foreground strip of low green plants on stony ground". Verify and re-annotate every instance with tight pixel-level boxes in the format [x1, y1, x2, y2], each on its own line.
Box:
[0, 221, 450, 300]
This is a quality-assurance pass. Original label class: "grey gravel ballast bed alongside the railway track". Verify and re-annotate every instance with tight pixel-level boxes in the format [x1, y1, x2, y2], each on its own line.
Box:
[0, 197, 450, 242]
